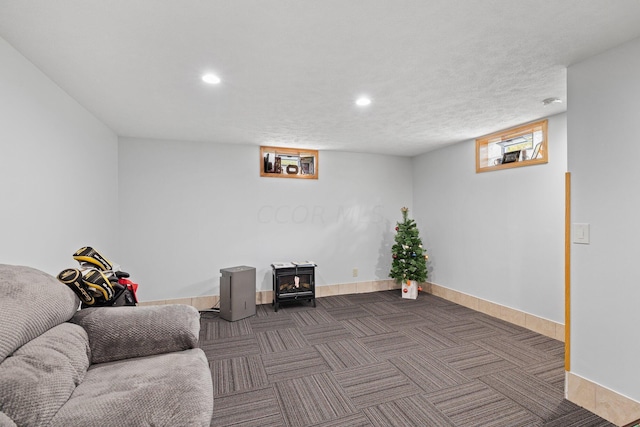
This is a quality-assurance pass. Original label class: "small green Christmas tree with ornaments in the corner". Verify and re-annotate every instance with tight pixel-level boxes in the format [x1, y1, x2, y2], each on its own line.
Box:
[389, 208, 429, 283]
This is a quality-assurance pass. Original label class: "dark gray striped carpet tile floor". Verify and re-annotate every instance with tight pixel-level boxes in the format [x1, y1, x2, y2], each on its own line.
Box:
[200, 291, 613, 427]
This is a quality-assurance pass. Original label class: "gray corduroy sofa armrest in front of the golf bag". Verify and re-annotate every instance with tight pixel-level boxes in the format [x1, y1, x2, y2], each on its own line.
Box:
[71, 304, 200, 363]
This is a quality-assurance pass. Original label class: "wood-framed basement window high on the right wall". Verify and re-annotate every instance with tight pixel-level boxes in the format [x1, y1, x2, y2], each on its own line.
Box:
[476, 120, 549, 172]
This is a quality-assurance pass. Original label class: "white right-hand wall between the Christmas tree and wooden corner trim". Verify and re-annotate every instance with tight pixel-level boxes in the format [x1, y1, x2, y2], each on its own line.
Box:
[413, 114, 567, 323]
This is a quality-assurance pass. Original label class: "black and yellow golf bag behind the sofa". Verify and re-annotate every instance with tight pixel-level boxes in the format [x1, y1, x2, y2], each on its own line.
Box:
[58, 246, 138, 308]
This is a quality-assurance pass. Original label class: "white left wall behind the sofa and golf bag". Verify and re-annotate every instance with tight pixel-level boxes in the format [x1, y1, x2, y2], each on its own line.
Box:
[0, 38, 118, 275]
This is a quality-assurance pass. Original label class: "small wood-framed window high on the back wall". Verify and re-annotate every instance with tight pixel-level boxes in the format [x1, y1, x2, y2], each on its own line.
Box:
[260, 146, 319, 179]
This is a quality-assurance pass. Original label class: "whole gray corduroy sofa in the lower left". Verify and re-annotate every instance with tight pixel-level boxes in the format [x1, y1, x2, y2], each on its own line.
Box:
[0, 264, 213, 427]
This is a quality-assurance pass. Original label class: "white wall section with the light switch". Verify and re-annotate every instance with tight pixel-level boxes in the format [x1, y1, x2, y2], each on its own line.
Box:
[568, 39, 640, 401]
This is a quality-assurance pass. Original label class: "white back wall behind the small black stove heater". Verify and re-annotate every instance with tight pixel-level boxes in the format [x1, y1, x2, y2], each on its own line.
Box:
[119, 138, 412, 301]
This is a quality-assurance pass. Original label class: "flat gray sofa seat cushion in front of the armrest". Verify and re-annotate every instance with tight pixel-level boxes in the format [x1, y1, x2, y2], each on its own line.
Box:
[51, 348, 213, 427]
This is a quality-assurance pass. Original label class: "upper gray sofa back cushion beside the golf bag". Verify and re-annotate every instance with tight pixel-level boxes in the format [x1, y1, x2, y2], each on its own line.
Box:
[0, 264, 80, 363]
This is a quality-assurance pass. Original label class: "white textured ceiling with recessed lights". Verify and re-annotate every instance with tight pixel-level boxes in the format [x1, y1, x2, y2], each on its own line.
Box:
[0, 0, 640, 156]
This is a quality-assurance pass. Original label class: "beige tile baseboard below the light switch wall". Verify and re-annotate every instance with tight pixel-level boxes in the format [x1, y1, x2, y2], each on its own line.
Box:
[564, 372, 640, 426]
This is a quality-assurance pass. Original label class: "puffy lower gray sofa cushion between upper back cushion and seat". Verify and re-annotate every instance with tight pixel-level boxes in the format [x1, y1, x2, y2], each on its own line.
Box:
[0, 323, 90, 426]
